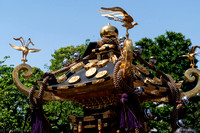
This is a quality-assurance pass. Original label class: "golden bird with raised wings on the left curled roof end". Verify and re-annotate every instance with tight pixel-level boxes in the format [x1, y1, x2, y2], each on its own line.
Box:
[10, 37, 41, 63]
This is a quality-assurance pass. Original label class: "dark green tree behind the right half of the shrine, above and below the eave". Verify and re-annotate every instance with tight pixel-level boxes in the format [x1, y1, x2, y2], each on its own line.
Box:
[136, 31, 200, 132]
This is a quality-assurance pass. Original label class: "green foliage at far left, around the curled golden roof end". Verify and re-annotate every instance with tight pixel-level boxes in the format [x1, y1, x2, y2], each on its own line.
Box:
[0, 56, 43, 131]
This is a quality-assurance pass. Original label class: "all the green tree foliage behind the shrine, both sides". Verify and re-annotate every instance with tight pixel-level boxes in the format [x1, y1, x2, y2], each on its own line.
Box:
[0, 32, 200, 133]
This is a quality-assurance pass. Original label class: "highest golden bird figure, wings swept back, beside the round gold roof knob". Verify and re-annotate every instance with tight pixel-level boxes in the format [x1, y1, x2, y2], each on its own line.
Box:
[99, 7, 138, 38]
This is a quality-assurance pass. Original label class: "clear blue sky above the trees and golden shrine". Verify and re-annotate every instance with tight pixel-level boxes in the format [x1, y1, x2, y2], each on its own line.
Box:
[0, 0, 200, 71]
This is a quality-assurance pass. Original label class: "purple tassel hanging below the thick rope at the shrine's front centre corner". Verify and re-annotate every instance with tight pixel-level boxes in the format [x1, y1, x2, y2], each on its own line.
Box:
[120, 93, 142, 129]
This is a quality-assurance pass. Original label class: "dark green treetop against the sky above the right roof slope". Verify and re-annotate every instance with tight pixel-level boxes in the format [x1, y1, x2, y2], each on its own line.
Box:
[136, 31, 191, 81]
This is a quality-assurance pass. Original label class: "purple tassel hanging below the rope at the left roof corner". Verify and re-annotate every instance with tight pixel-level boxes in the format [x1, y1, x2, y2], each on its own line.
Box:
[31, 107, 50, 133]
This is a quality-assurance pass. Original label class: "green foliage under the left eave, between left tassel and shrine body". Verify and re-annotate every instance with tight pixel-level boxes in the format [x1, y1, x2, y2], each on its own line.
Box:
[43, 101, 83, 132]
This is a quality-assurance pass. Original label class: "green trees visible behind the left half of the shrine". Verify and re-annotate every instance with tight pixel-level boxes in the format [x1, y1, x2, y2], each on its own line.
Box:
[0, 40, 89, 132]
